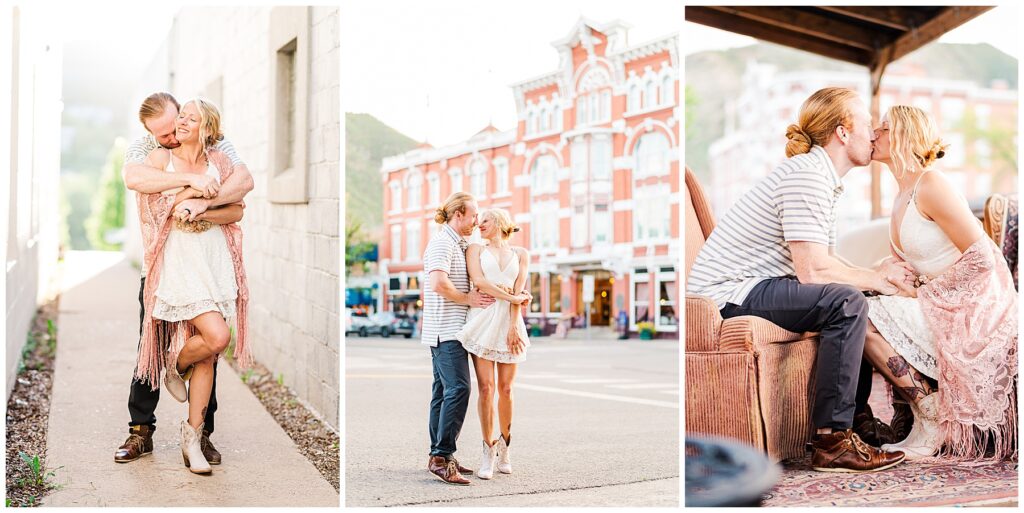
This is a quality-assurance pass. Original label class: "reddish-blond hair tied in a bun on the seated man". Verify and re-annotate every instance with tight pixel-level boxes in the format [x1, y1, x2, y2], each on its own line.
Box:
[785, 87, 858, 158]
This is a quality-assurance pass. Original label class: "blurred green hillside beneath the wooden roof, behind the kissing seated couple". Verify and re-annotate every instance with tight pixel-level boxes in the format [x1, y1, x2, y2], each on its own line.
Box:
[686, 43, 1018, 180]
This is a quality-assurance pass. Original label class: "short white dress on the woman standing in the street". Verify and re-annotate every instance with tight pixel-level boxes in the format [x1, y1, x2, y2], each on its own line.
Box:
[455, 249, 529, 364]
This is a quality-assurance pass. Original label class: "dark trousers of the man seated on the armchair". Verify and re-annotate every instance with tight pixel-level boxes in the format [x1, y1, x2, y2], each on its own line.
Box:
[722, 277, 871, 429]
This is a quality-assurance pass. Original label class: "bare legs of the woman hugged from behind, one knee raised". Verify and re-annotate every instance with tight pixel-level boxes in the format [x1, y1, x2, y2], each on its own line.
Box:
[186, 311, 230, 428]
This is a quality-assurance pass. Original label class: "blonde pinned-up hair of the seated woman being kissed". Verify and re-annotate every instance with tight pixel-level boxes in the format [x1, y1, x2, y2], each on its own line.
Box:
[886, 105, 948, 177]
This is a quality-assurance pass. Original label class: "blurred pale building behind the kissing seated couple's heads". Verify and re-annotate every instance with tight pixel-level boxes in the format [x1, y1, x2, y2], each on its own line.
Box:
[706, 61, 1017, 231]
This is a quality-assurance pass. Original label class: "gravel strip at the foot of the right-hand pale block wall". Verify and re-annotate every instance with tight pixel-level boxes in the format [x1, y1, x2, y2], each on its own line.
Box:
[227, 358, 341, 493]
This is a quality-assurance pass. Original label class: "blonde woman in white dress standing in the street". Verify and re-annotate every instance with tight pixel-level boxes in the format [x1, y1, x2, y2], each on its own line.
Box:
[456, 205, 529, 479]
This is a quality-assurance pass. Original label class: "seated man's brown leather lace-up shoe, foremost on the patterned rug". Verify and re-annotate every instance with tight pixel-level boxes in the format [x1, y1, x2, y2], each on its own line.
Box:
[811, 429, 906, 473]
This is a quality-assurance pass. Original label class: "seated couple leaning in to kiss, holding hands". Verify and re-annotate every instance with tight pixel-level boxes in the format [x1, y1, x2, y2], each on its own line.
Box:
[688, 87, 1018, 472]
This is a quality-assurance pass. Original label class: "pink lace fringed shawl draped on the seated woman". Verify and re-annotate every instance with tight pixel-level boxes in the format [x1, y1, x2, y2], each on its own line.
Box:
[918, 237, 1017, 459]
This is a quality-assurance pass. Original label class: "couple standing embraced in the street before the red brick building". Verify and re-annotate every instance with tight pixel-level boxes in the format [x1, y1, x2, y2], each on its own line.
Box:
[421, 193, 532, 485]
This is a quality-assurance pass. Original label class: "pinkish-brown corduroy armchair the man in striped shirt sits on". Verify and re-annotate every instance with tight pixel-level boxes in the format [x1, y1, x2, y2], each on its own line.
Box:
[685, 168, 818, 461]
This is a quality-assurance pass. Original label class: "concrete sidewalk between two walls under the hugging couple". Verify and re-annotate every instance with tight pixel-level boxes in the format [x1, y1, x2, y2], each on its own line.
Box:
[43, 252, 339, 507]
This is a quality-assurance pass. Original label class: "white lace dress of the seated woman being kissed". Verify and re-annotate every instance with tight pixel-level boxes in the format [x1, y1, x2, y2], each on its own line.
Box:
[867, 179, 966, 379]
